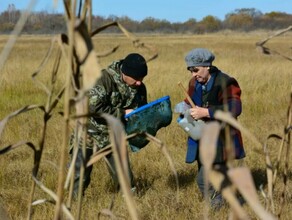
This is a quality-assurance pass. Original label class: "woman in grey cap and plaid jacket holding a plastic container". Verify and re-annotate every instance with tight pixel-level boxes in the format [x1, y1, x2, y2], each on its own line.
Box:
[177, 48, 245, 208]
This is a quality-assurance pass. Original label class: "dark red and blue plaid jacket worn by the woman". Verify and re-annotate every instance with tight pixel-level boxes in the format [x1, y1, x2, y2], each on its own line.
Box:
[185, 66, 245, 163]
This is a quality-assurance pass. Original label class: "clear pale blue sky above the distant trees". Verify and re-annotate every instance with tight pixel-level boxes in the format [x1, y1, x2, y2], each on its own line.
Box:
[0, 0, 292, 22]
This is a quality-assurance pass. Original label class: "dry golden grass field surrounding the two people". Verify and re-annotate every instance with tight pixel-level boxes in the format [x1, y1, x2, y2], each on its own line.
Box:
[0, 32, 292, 220]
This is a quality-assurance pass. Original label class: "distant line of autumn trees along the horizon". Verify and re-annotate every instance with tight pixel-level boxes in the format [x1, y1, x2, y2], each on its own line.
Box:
[0, 7, 292, 34]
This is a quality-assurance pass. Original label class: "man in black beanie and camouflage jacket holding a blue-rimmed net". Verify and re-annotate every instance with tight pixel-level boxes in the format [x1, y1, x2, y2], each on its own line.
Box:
[70, 53, 148, 197]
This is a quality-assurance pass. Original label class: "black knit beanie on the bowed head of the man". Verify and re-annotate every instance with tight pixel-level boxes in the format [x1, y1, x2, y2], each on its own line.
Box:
[121, 53, 148, 79]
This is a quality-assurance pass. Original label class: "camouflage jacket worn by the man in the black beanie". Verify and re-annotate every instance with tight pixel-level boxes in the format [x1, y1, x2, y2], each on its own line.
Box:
[88, 60, 147, 148]
